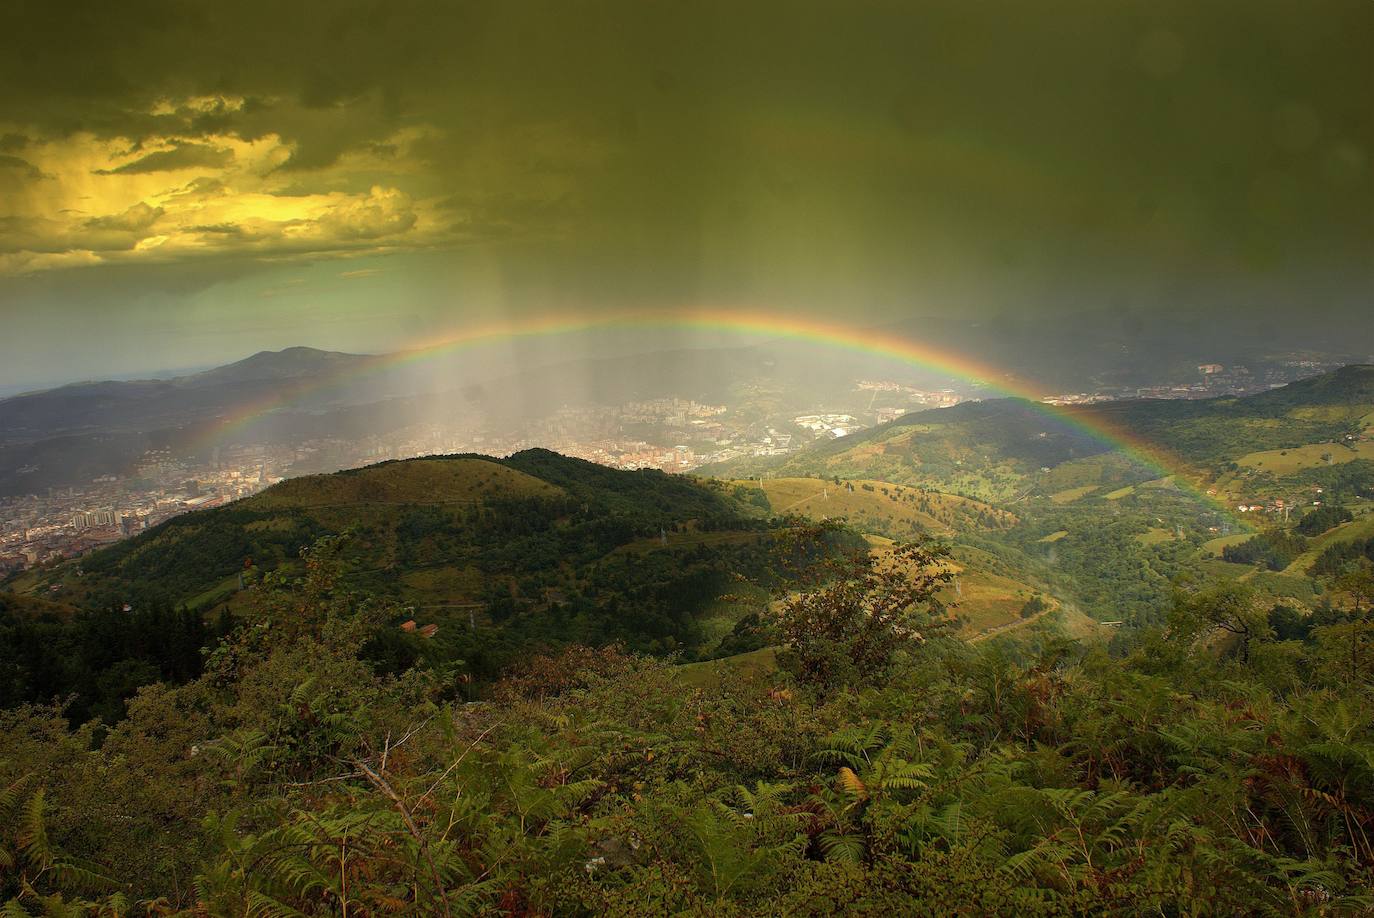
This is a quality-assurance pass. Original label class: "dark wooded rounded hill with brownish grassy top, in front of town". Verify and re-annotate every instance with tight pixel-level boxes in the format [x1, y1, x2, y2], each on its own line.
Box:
[0, 449, 840, 716]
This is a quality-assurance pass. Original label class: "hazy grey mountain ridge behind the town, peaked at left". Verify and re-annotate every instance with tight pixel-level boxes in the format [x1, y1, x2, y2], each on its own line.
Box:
[0, 336, 868, 495]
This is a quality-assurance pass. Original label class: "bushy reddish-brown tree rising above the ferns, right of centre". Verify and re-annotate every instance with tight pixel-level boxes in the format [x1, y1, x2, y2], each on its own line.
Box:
[779, 541, 954, 687]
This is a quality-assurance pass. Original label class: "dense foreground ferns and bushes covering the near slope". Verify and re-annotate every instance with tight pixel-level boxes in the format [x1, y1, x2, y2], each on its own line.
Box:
[0, 530, 1374, 915]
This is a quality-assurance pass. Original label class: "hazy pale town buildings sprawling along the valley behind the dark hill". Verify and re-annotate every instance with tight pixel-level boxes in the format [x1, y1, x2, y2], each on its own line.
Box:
[0, 359, 1337, 576]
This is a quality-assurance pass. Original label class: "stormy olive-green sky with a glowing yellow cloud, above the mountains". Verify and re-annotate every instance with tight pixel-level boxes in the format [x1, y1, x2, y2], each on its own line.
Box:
[0, 0, 1374, 386]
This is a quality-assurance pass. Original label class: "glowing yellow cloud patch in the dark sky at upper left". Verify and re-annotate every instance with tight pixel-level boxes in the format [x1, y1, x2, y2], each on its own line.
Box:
[0, 103, 452, 273]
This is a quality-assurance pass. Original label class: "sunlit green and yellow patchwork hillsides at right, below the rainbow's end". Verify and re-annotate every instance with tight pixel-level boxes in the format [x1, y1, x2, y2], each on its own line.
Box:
[708, 366, 1374, 628]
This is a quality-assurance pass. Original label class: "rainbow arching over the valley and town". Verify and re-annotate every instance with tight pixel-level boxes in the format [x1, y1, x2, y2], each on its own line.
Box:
[194, 309, 1217, 504]
